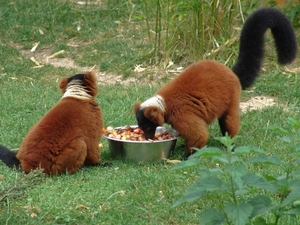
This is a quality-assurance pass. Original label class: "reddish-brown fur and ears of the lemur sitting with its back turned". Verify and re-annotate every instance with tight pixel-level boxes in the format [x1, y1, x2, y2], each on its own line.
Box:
[17, 72, 103, 174]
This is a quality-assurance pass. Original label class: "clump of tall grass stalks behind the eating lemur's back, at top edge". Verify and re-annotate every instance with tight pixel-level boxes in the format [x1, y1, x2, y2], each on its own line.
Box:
[143, 0, 259, 66]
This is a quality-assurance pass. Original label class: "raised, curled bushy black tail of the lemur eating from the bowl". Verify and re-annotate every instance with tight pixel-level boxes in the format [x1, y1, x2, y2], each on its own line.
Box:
[232, 8, 297, 89]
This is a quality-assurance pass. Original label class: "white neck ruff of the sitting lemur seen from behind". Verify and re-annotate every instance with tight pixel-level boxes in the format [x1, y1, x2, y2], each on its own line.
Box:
[62, 80, 93, 100]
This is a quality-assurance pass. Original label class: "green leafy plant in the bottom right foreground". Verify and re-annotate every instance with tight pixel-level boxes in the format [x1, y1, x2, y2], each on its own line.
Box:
[172, 118, 300, 224]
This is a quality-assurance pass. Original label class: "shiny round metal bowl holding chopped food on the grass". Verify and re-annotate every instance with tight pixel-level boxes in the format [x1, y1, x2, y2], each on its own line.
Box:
[103, 125, 179, 163]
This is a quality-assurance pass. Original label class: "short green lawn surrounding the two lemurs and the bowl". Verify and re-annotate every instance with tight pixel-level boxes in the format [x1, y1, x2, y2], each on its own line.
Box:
[0, 0, 300, 224]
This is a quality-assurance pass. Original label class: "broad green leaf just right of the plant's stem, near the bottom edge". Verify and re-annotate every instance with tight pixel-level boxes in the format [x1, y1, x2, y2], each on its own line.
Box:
[248, 195, 272, 218]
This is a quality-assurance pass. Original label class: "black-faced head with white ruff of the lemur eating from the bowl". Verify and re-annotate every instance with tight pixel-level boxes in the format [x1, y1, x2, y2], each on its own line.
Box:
[133, 95, 165, 139]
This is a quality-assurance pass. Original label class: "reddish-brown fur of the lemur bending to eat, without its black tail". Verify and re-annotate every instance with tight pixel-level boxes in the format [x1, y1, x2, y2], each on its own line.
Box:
[134, 61, 241, 152]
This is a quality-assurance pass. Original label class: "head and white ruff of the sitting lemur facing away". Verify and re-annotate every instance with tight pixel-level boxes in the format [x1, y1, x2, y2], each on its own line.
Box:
[59, 72, 98, 99]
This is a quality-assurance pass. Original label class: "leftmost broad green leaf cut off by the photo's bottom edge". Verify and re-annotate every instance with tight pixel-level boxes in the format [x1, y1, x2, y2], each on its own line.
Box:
[200, 208, 226, 225]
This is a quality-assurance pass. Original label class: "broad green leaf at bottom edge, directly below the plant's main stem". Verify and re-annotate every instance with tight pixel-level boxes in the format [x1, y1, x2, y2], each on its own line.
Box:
[224, 203, 253, 225]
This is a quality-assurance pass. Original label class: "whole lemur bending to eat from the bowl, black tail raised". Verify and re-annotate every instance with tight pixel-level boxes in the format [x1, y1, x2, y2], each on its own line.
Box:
[133, 8, 297, 155]
